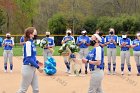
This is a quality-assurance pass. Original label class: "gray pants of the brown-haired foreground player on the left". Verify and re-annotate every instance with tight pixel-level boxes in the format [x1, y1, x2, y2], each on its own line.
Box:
[17, 65, 39, 93]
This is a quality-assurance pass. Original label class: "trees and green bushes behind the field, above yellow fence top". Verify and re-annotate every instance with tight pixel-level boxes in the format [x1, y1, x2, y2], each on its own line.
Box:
[0, 0, 140, 34]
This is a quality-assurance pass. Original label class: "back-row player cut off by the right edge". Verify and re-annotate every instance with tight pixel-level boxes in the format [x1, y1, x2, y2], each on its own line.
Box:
[132, 32, 140, 76]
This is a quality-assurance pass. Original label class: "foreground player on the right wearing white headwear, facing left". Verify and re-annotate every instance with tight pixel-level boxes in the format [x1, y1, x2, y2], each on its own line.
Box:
[82, 34, 104, 93]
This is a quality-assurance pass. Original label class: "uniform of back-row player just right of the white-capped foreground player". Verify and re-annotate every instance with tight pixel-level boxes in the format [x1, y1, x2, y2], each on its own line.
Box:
[105, 35, 118, 72]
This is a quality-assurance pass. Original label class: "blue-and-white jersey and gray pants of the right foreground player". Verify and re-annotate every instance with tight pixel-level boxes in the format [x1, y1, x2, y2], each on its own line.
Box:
[86, 46, 104, 93]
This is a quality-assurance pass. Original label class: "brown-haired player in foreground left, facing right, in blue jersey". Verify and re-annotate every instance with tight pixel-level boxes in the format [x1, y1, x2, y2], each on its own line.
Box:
[17, 27, 43, 93]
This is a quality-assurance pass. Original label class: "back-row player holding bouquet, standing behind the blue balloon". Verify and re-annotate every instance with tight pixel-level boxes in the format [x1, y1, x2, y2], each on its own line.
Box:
[43, 32, 55, 62]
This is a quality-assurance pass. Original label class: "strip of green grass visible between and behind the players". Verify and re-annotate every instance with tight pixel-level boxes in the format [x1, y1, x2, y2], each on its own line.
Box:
[0, 46, 133, 56]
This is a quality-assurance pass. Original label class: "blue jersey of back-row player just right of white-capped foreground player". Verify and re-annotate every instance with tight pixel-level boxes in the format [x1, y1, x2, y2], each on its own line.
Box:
[105, 35, 118, 48]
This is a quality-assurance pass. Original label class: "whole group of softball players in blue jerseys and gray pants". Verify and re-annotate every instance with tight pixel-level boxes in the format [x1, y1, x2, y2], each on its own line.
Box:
[3, 27, 140, 93]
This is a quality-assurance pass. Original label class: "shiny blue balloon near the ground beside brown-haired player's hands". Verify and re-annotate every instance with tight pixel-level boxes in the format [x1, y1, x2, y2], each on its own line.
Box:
[44, 57, 57, 75]
